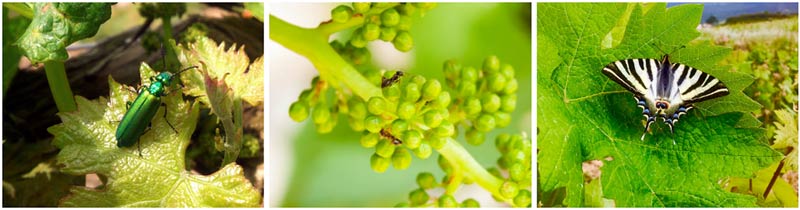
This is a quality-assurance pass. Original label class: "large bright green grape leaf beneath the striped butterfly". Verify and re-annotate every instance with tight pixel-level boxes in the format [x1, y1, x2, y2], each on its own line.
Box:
[537, 3, 781, 207]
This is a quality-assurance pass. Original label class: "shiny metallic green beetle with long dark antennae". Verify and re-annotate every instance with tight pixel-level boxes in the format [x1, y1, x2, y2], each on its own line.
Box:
[116, 66, 197, 156]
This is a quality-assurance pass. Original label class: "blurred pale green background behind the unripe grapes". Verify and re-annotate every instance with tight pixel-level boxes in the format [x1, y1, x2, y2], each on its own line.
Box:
[268, 3, 532, 207]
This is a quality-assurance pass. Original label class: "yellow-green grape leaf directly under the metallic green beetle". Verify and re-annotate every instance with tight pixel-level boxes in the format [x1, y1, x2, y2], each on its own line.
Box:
[48, 64, 261, 207]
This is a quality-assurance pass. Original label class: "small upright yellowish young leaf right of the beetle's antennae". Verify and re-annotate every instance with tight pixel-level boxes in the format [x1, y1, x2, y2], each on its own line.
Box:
[178, 37, 264, 164]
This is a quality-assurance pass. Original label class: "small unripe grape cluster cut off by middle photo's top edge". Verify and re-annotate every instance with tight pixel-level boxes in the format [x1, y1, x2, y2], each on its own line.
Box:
[331, 2, 436, 52]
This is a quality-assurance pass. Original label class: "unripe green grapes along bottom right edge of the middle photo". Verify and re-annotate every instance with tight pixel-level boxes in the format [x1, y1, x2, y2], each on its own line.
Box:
[404, 134, 531, 208]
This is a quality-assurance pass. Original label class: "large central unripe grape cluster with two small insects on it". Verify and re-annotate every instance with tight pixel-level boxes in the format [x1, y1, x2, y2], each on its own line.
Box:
[289, 56, 517, 173]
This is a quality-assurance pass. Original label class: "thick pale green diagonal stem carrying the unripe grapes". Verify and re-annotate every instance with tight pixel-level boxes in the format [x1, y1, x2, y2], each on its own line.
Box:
[269, 15, 513, 203]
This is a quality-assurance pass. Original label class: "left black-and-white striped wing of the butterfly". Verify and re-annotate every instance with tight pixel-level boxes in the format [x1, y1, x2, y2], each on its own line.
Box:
[603, 59, 661, 96]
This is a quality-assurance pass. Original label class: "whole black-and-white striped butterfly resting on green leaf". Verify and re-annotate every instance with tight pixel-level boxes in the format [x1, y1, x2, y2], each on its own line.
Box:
[603, 55, 728, 144]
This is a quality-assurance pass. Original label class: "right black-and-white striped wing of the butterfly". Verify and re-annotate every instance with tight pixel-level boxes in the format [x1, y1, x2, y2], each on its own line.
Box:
[672, 63, 729, 104]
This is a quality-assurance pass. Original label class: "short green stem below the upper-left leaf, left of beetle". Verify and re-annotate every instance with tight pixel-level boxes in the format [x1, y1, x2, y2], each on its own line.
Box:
[44, 61, 78, 112]
